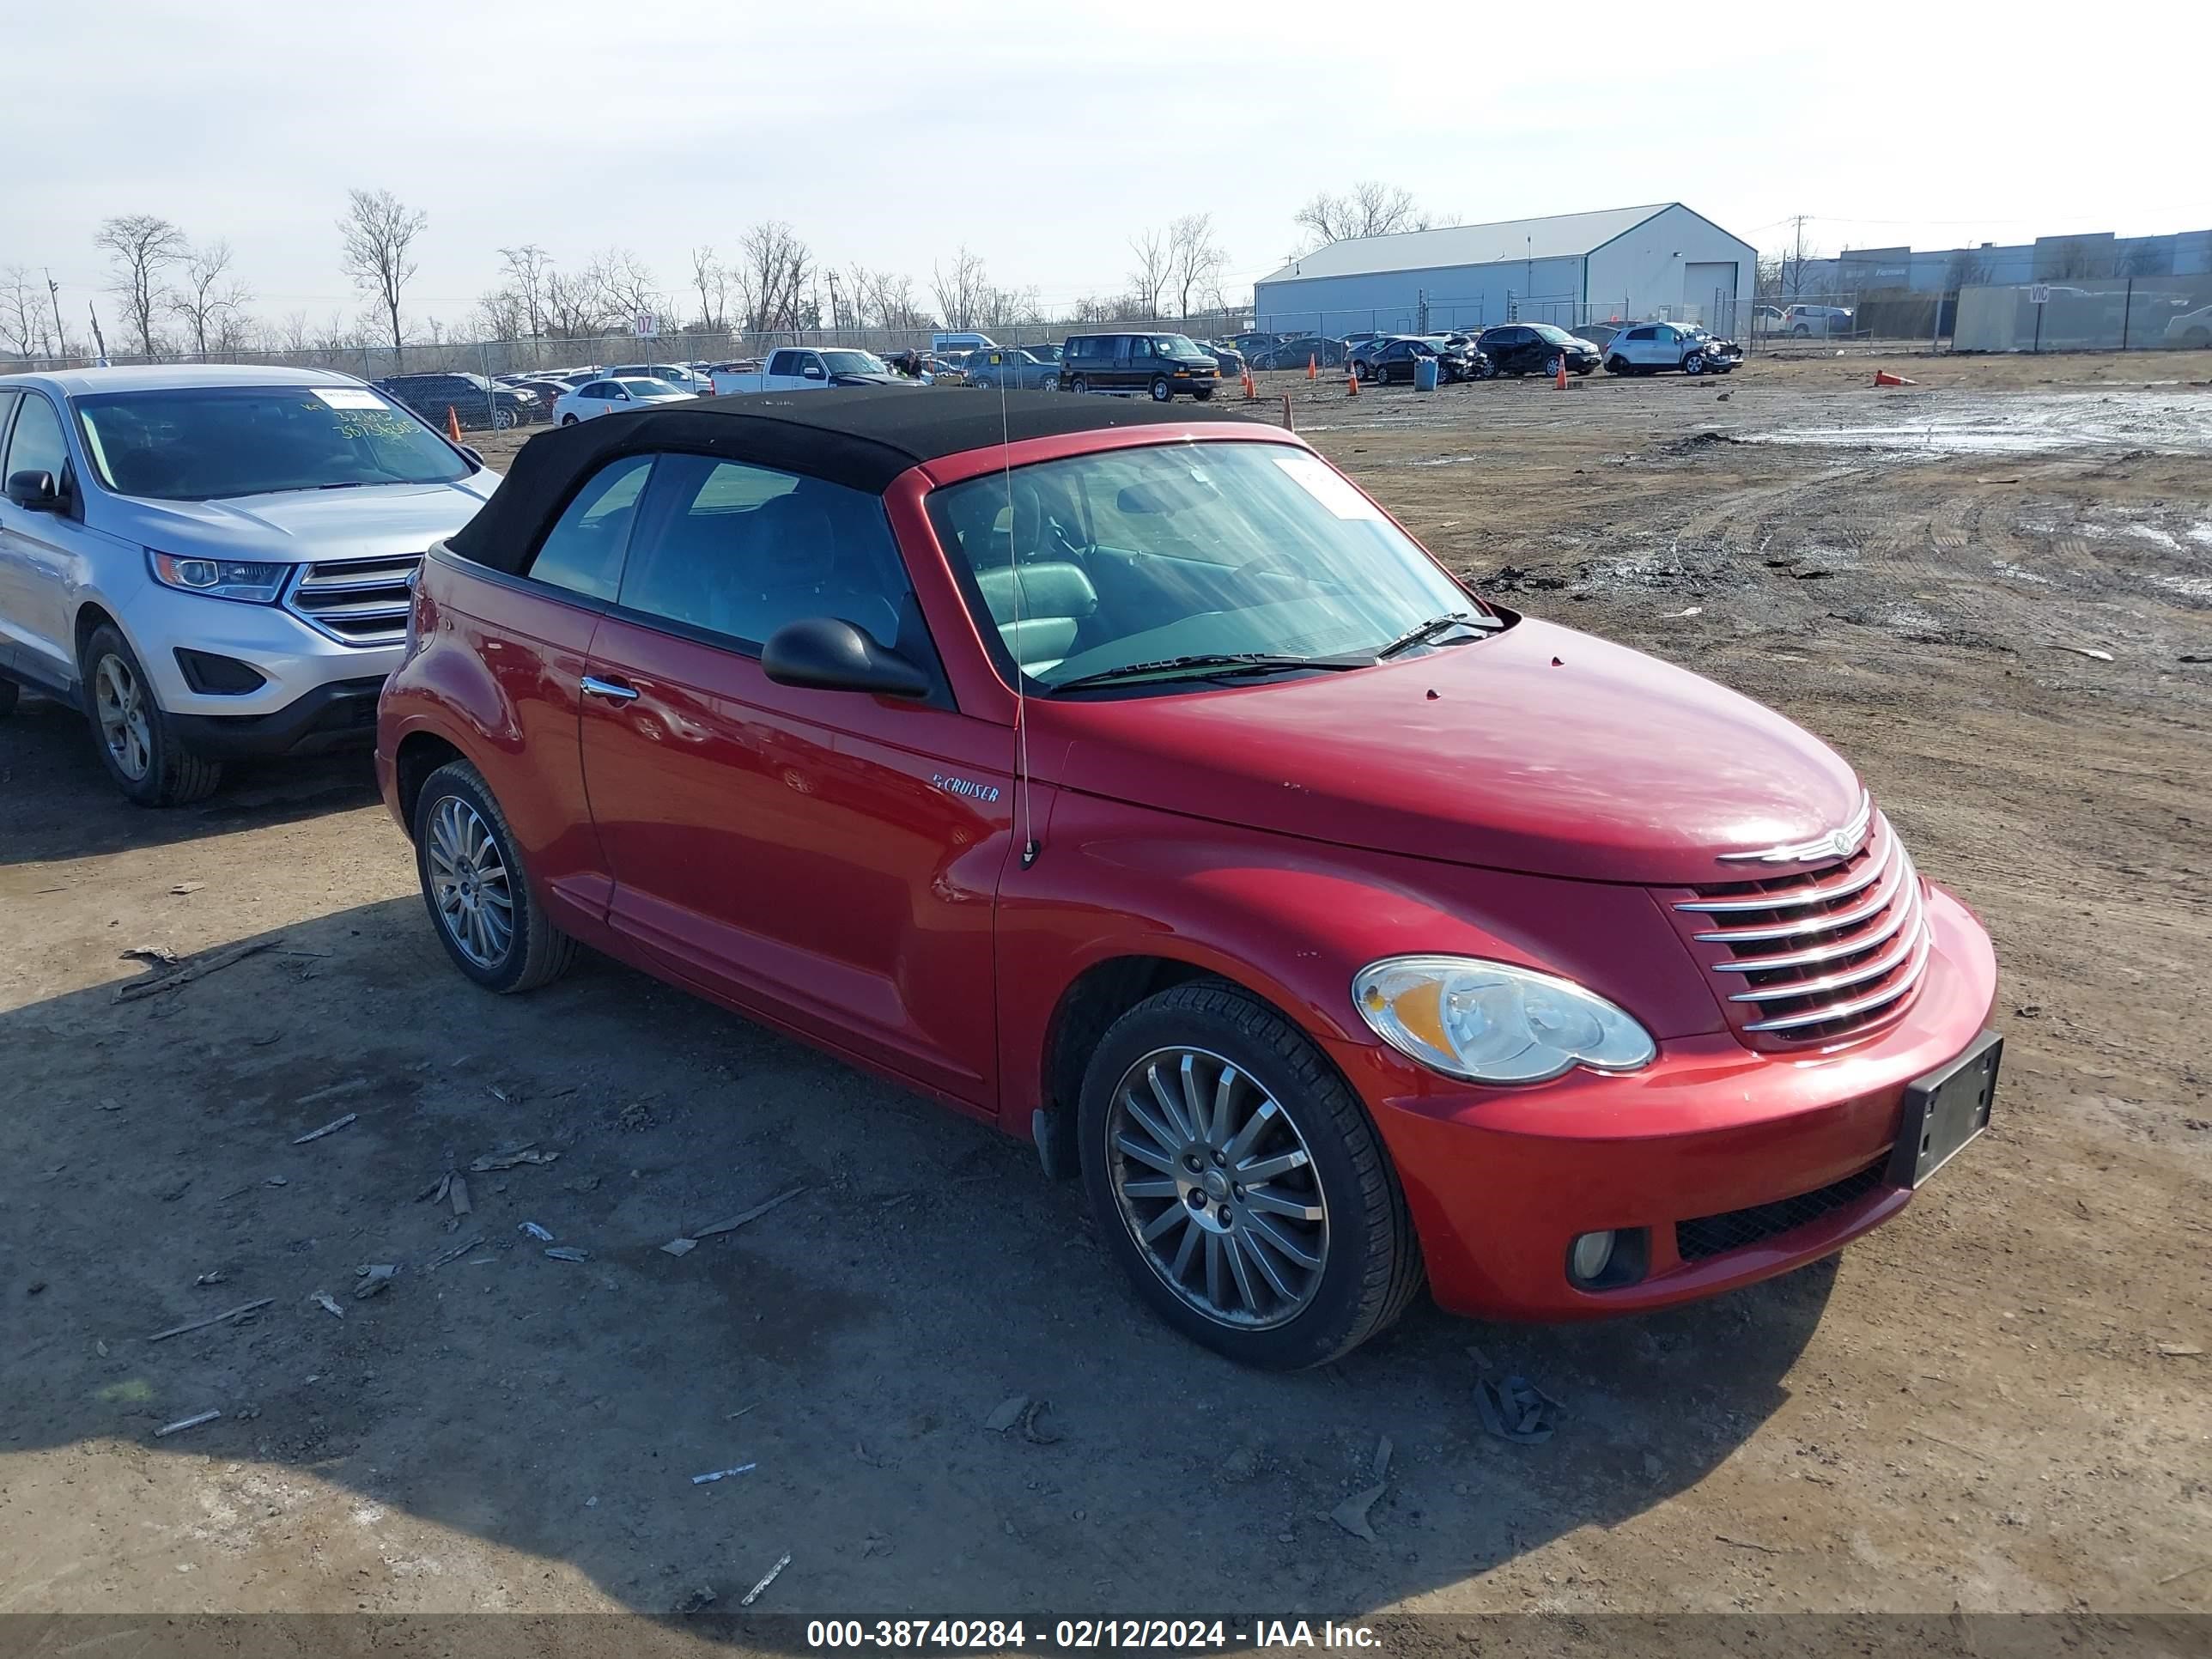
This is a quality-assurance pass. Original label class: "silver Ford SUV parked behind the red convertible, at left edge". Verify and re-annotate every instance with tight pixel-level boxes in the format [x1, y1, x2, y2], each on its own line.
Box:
[0, 365, 498, 805]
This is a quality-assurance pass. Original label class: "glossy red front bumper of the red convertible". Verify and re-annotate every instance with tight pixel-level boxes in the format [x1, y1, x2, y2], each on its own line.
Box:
[1336, 887, 1997, 1321]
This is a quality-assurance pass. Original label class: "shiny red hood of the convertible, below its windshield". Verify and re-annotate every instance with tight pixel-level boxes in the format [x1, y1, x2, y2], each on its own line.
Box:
[1029, 619, 1860, 887]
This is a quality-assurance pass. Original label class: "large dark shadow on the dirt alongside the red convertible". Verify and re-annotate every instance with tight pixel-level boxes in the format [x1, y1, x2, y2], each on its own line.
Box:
[0, 898, 1832, 1648]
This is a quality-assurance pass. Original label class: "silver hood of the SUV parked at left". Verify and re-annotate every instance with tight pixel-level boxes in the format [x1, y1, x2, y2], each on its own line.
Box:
[108, 467, 500, 562]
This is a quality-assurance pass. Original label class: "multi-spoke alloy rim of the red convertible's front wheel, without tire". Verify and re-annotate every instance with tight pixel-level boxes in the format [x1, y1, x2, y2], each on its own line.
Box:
[1106, 1046, 1329, 1329]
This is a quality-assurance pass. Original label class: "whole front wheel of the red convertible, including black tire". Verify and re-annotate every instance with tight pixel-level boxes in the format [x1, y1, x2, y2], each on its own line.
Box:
[1078, 980, 1422, 1371]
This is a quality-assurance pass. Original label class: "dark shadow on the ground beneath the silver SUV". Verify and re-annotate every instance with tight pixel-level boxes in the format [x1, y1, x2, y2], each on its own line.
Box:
[0, 692, 376, 865]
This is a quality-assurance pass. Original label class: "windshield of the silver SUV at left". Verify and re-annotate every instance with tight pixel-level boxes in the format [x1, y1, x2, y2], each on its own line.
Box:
[76, 385, 469, 502]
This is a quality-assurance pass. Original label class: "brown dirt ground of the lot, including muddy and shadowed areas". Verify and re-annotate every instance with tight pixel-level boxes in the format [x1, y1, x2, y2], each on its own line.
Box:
[0, 354, 2212, 1617]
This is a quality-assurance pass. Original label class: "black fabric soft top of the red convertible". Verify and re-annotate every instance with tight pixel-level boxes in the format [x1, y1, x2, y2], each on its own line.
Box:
[447, 387, 1241, 571]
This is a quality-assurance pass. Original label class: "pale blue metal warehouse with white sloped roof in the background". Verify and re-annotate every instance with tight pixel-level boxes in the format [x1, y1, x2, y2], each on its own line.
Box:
[1252, 201, 1759, 337]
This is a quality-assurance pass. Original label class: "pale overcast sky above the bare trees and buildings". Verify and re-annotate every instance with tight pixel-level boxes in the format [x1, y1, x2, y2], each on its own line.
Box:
[0, 0, 2212, 338]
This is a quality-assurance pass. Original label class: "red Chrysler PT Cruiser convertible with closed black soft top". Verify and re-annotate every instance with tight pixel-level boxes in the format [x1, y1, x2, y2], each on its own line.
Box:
[376, 389, 1997, 1367]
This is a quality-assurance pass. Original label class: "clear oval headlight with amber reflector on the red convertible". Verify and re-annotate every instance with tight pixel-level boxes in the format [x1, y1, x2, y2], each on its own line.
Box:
[1352, 956, 1659, 1084]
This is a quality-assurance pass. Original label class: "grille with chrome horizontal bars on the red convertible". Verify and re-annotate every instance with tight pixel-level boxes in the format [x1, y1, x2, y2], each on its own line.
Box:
[1670, 811, 1931, 1048]
